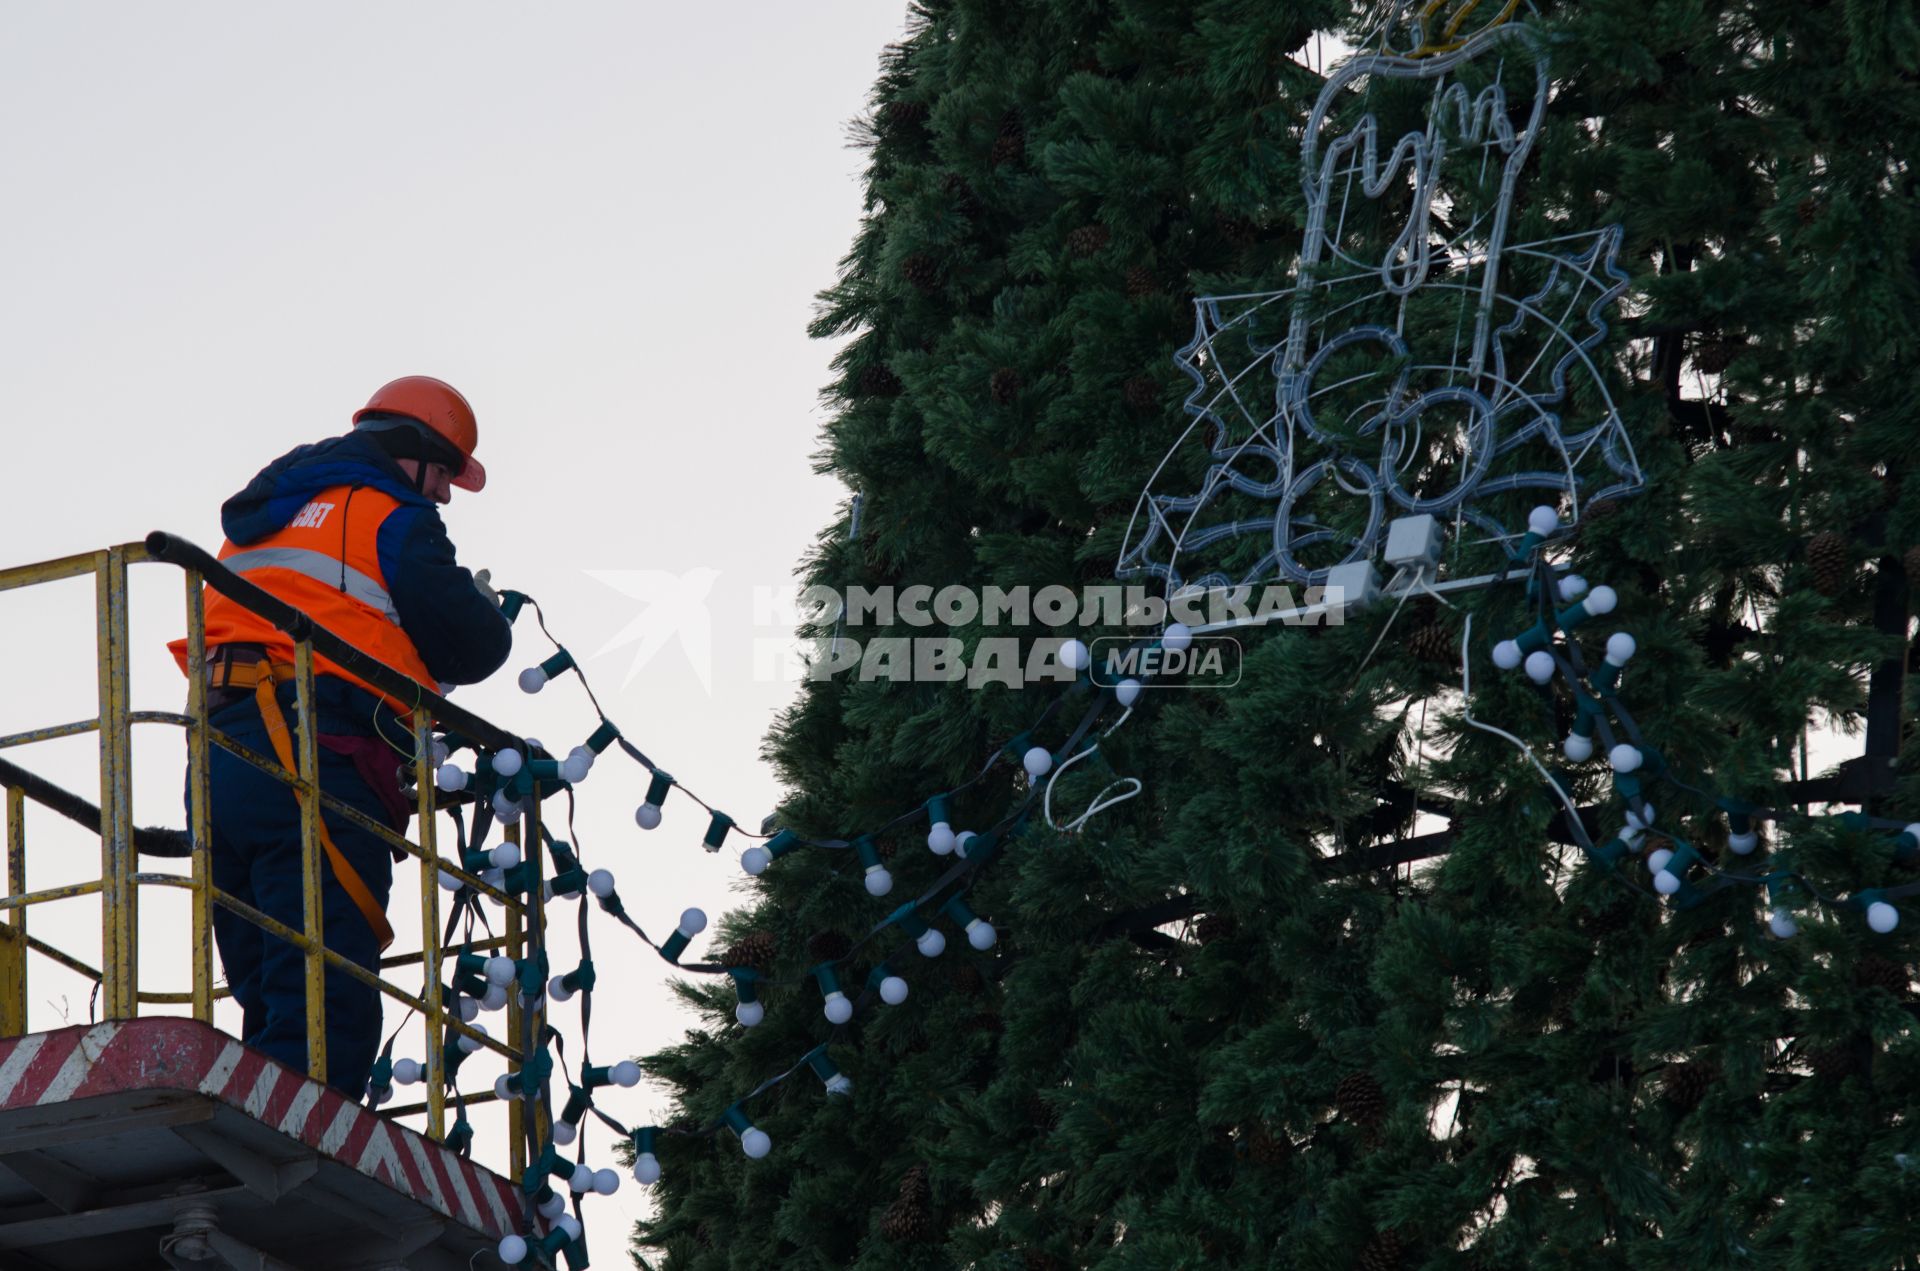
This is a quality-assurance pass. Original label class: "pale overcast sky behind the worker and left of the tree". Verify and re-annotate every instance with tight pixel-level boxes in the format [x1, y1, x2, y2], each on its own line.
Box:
[0, 0, 904, 1267]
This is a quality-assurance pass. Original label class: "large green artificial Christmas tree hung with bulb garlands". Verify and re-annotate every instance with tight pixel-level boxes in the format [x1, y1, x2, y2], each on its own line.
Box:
[637, 0, 1920, 1271]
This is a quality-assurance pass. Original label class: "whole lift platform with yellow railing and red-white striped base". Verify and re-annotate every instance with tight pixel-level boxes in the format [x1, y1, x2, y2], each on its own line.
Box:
[0, 534, 568, 1271]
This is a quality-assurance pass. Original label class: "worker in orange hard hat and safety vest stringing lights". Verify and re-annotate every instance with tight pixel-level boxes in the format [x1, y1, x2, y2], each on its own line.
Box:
[173, 374, 513, 1098]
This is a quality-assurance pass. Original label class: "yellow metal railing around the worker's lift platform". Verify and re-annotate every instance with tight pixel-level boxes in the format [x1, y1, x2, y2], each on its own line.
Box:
[0, 534, 545, 1179]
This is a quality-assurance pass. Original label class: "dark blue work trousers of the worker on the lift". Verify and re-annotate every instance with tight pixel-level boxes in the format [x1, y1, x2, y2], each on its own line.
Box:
[194, 683, 397, 1100]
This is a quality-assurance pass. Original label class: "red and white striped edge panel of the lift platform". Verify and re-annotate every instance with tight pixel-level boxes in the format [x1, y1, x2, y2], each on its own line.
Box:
[0, 1018, 520, 1238]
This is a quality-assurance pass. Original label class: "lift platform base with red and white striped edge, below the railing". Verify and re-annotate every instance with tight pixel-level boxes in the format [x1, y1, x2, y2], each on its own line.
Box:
[0, 1018, 522, 1271]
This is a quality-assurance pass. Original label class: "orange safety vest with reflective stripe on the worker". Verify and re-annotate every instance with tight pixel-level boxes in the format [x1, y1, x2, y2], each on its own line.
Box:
[167, 486, 440, 712]
